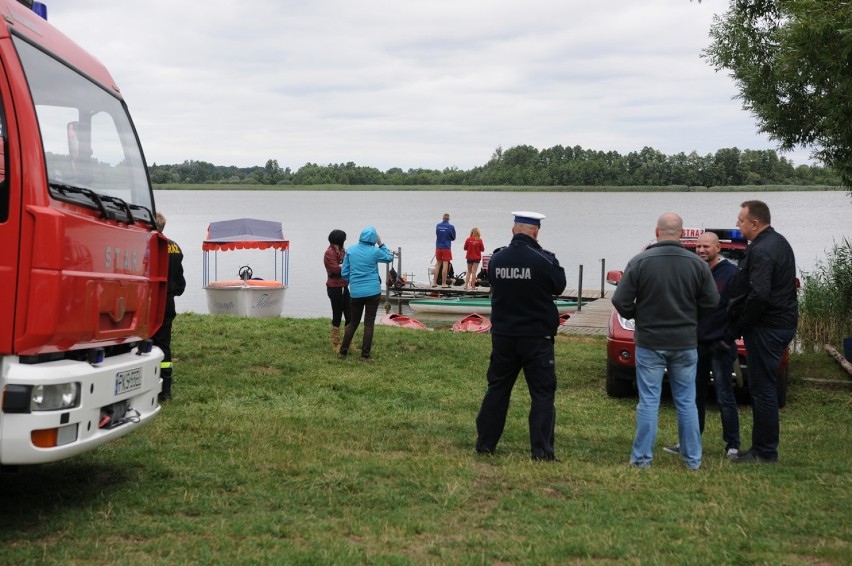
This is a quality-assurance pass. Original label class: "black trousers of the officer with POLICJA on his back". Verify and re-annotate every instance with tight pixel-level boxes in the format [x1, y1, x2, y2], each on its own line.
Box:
[476, 334, 556, 460]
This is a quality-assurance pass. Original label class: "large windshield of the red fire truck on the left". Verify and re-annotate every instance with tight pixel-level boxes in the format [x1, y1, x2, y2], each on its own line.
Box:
[15, 33, 153, 223]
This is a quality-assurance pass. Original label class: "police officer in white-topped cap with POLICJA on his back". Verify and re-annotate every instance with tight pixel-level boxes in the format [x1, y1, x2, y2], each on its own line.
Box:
[476, 211, 565, 460]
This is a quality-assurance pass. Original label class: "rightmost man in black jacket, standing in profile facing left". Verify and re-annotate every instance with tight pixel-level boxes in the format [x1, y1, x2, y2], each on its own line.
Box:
[727, 200, 799, 464]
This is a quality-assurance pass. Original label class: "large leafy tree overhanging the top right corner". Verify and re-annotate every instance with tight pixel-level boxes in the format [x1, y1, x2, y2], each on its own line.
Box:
[704, 0, 852, 188]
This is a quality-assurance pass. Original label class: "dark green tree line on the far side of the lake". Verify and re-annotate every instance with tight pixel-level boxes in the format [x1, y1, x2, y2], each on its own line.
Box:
[149, 145, 840, 187]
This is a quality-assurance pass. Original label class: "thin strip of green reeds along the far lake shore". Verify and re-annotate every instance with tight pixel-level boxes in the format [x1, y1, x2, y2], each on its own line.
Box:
[153, 183, 847, 193]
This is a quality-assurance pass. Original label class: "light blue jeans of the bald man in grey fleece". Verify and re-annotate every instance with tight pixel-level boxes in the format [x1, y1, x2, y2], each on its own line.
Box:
[630, 346, 701, 470]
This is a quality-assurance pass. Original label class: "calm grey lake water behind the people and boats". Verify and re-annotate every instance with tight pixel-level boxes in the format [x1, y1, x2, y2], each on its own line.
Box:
[155, 191, 852, 318]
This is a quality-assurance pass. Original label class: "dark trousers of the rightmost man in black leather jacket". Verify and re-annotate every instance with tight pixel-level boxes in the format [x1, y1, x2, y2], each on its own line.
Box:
[743, 326, 796, 461]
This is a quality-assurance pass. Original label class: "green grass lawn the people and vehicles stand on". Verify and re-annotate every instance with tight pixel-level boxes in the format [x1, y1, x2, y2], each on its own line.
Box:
[0, 314, 852, 564]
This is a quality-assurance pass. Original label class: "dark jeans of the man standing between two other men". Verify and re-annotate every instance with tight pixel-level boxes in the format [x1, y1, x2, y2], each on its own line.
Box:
[695, 341, 740, 450]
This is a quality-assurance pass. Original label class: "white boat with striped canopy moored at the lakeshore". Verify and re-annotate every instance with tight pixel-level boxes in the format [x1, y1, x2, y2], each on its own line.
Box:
[201, 218, 290, 318]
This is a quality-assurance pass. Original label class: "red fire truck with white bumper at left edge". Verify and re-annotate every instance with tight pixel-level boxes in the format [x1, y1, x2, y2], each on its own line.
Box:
[0, 0, 168, 465]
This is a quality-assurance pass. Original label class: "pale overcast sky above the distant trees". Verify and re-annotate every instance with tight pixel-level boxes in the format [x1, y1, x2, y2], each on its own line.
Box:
[44, 0, 808, 171]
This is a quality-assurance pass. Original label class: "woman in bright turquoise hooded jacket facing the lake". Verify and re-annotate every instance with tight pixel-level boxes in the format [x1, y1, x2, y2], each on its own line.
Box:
[339, 226, 393, 360]
